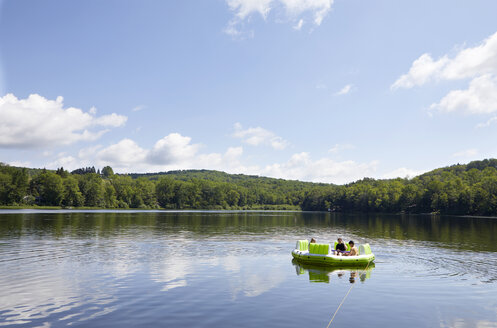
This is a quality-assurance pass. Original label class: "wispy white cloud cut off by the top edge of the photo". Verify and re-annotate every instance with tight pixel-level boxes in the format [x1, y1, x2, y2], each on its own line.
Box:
[224, 0, 334, 37]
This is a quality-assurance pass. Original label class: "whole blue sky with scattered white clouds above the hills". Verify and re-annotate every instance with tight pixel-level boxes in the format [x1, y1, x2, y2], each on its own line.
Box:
[0, 0, 497, 184]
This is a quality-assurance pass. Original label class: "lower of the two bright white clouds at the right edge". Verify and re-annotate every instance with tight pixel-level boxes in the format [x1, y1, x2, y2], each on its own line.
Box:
[430, 74, 497, 114]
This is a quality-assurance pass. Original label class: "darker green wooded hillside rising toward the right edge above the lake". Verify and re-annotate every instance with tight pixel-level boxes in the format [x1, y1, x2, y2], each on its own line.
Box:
[301, 159, 497, 215]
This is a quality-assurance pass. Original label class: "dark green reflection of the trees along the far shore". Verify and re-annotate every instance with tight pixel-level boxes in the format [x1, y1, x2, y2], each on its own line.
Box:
[0, 210, 497, 252]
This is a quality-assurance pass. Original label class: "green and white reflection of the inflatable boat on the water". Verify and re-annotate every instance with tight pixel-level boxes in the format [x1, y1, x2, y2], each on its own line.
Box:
[292, 259, 375, 284]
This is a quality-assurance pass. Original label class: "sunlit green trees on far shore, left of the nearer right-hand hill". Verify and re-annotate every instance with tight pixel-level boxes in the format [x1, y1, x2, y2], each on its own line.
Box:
[0, 164, 306, 209]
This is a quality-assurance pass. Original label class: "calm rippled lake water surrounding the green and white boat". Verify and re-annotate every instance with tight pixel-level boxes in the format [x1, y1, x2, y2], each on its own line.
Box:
[0, 210, 497, 328]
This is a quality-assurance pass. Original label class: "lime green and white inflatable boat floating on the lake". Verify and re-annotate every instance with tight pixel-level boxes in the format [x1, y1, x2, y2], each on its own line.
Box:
[292, 240, 374, 266]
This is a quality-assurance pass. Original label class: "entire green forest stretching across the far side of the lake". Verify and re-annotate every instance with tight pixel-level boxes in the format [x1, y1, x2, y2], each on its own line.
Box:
[0, 159, 497, 215]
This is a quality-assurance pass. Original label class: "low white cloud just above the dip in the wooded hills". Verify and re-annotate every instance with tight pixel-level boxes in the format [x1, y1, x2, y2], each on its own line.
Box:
[261, 152, 378, 184]
